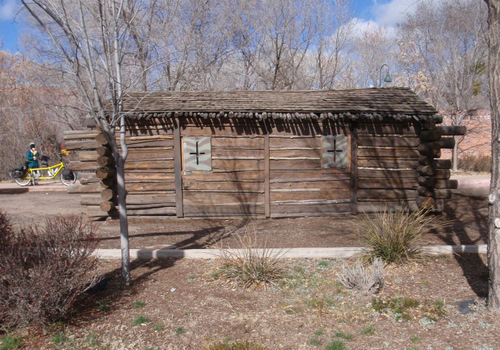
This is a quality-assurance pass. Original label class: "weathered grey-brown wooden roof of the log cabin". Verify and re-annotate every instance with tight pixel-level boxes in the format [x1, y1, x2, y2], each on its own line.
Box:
[116, 87, 437, 120]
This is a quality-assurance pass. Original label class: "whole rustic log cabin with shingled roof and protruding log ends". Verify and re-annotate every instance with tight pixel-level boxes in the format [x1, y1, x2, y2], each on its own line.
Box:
[65, 88, 465, 219]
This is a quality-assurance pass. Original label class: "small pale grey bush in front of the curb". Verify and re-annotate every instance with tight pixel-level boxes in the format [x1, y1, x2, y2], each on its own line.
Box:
[339, 258, 384, 293]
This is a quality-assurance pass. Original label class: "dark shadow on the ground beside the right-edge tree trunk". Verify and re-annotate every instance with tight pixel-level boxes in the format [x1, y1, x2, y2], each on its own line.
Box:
[433, 195, 489, 297]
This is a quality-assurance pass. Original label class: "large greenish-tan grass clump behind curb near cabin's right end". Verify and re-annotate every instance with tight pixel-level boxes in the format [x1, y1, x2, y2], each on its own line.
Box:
[357, 207, 438, 263]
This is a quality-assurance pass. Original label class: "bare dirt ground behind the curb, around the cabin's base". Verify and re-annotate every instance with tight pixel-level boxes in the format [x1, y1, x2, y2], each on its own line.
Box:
[0, 187, 488, 249]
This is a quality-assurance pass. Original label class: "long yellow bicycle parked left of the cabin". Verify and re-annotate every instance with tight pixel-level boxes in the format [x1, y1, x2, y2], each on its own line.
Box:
[10, 150, 78, 186]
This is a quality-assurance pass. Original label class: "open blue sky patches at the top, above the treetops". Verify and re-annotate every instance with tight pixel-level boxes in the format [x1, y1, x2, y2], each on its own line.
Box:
[0, 0, 418, 53]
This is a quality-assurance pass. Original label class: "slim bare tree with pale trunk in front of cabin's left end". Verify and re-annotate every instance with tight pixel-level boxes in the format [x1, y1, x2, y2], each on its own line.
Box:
[21, 0, 152, 285]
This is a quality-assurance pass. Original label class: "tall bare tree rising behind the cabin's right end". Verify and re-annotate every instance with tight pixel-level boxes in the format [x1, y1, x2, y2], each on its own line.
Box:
[398, 0, 488, 170]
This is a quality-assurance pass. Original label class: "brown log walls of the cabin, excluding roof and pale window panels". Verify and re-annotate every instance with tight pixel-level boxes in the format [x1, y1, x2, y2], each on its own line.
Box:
[65, 118, 456, 218]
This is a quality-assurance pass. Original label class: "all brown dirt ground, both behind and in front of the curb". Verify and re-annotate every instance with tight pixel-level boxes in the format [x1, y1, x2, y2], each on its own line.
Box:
[0, 185, 500, 350]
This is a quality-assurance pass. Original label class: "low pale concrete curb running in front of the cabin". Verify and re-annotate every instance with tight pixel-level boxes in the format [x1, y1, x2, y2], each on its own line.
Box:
[92, 244, 487, 259]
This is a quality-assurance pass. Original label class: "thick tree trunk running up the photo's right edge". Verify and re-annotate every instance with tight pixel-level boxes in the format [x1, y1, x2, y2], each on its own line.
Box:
[485, 0, 500, 314]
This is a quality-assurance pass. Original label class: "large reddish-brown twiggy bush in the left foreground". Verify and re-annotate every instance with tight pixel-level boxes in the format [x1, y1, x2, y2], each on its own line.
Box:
[0, 213, 98, 327]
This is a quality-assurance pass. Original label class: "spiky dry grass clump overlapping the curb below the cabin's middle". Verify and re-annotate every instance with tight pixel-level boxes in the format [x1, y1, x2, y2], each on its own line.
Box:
[217, 228, 284, 288]
